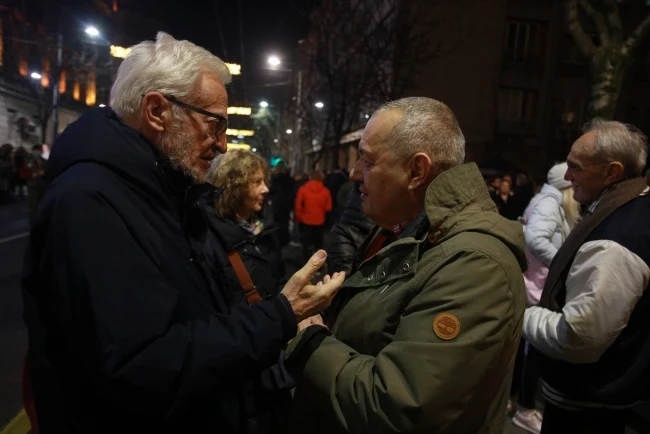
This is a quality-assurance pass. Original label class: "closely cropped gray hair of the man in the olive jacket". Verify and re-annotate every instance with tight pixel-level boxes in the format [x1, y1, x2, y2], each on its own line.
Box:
[375, 97, 465, 172]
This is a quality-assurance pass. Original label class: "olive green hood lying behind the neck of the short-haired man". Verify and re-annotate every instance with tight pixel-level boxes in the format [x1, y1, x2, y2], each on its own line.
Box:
[424, 163, 527, 272]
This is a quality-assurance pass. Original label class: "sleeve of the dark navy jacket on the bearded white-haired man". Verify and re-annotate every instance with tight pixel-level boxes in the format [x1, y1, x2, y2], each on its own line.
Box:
[51, 187, 296, 417]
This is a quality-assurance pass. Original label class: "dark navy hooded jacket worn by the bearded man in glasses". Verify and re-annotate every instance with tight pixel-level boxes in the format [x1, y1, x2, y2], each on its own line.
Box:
[23, 109, 296, 434]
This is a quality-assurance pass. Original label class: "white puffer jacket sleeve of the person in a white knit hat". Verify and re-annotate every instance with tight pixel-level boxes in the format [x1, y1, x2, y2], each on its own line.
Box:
[526, 196, 562, 267]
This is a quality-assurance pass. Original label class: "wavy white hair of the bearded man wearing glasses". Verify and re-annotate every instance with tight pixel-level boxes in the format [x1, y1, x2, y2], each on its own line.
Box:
[110, 32, 231, 117]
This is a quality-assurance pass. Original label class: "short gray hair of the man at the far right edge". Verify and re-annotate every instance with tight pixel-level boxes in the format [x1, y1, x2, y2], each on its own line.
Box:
[583, 118, 648, 179]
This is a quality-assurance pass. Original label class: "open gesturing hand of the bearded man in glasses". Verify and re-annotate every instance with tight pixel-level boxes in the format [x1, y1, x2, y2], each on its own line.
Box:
[282, 250, 345, 322]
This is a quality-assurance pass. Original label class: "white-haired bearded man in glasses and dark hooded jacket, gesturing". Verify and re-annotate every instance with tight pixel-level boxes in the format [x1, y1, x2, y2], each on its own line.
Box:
[23, 33, 343, 433]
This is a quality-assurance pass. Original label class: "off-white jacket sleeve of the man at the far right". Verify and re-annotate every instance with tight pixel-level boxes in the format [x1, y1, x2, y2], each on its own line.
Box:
[523, 240, 650, 363]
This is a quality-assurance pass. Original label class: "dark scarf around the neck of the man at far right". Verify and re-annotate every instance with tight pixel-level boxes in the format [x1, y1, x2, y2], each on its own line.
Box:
[540, 177, 648, 312]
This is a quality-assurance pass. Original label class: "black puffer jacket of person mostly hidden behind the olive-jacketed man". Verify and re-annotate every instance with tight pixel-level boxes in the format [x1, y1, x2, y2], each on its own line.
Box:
[325, 187, 375, 276]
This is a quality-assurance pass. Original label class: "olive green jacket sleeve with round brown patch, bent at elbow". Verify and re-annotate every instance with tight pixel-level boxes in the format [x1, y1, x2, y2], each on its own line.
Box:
[287, 252, 523, 434]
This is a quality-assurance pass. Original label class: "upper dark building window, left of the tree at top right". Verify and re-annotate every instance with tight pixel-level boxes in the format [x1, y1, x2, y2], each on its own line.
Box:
[504, 21, 546, 65]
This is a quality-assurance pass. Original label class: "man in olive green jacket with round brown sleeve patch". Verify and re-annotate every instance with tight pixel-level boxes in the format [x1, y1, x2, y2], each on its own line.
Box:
[286, 98, 526, 434]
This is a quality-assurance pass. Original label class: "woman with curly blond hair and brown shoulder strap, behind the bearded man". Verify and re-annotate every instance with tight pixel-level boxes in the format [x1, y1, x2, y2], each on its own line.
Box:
[206, 149, 294, 433]
